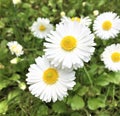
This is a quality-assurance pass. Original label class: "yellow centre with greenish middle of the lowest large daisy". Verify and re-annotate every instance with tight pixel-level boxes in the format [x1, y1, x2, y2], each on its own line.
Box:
[43, 68, 58, 85]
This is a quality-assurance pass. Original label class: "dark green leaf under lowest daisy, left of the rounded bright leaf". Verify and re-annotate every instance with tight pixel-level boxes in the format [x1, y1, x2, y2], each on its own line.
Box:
[52, 101, 67, 113]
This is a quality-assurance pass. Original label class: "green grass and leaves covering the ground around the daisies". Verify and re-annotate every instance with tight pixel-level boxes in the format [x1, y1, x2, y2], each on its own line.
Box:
[0, 0, 120, 116]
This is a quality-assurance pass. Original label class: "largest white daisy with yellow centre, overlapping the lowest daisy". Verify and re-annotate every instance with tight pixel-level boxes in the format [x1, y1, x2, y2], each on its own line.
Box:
[44, 22, 95, 69]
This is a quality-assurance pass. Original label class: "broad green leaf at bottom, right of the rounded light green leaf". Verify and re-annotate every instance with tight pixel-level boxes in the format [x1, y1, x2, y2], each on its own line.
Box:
[88, 97, 105, 110]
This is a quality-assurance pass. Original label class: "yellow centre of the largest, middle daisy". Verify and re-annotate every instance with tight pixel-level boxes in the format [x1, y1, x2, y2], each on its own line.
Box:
[60, 36, 77, 51]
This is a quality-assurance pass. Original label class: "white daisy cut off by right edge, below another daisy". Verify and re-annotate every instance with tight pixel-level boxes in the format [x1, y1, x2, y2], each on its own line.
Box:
[101, 44, 120, 71]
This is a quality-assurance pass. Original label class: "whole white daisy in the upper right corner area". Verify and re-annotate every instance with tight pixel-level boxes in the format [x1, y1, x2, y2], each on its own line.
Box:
[93, 12, 120, 40]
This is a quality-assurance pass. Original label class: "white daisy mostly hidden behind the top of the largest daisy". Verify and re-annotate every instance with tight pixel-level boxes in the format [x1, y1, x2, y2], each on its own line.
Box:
[60, 16, 92, 26]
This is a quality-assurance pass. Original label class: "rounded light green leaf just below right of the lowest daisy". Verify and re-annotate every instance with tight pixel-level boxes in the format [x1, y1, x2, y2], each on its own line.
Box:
[70, 95, 85, 110]
